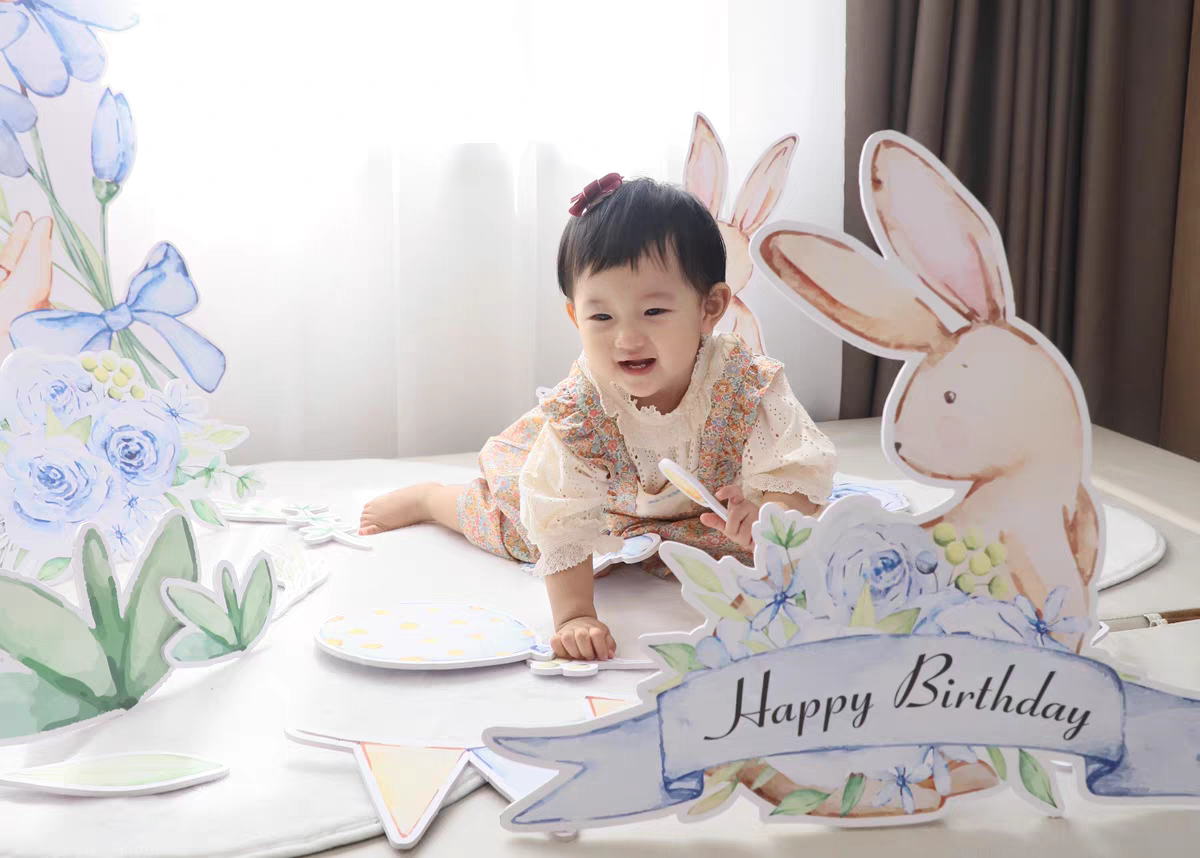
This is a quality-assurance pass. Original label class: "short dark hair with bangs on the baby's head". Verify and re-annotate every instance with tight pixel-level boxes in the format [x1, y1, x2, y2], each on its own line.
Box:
[558, 179, 725, 299]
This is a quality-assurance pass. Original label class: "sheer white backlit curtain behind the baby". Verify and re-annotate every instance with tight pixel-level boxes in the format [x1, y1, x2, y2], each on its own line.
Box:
[100, 0, 845, 461]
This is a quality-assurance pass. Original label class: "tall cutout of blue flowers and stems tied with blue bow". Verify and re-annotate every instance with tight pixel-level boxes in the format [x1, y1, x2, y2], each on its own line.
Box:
[0, 10, 226, 392]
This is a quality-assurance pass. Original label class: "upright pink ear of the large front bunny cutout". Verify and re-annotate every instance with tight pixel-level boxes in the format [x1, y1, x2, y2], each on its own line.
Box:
[863, 137, 1013, 322]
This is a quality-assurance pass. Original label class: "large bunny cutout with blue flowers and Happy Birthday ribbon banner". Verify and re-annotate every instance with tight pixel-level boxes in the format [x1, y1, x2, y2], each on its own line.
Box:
[484, 132, 1200, 830]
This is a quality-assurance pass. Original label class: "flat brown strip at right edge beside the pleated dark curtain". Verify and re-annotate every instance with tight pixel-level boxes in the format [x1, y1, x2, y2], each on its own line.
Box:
[1163, 1, 1200, 460]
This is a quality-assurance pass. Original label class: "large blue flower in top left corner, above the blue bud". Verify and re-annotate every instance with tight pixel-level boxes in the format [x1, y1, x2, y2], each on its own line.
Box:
[0, 0, 138, 96]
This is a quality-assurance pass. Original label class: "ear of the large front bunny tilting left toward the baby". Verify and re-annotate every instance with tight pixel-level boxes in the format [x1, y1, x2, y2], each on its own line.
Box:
[754, 226, 950, 359]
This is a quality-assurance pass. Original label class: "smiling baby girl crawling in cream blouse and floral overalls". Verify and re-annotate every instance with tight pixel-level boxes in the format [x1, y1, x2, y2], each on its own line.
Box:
[360, 173, 836, 660]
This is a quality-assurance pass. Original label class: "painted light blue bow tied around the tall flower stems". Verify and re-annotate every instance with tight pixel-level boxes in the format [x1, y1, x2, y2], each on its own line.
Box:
[8, 241, 226, 394]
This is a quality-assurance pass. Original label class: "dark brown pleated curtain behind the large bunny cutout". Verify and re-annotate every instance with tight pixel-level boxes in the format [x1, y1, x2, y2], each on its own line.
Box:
[841, 0, 1193, 456]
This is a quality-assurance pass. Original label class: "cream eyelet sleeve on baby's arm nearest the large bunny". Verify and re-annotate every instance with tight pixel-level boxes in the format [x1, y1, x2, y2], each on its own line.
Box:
[742, 372, 838, 505]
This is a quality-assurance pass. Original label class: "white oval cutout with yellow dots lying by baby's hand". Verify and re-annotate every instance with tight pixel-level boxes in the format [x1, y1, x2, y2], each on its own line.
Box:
[316, 601, 553, 671]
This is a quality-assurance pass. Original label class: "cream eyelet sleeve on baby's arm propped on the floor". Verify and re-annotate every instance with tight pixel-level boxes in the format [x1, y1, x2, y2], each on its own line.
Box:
[518, 422, 622, 576]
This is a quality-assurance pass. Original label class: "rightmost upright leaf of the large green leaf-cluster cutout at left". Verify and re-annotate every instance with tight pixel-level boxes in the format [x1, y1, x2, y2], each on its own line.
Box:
[121, 512, 199, 698]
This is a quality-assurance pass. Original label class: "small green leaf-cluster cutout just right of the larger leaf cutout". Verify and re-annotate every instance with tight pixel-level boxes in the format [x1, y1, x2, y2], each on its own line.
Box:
[162, 552, 278, 666]
